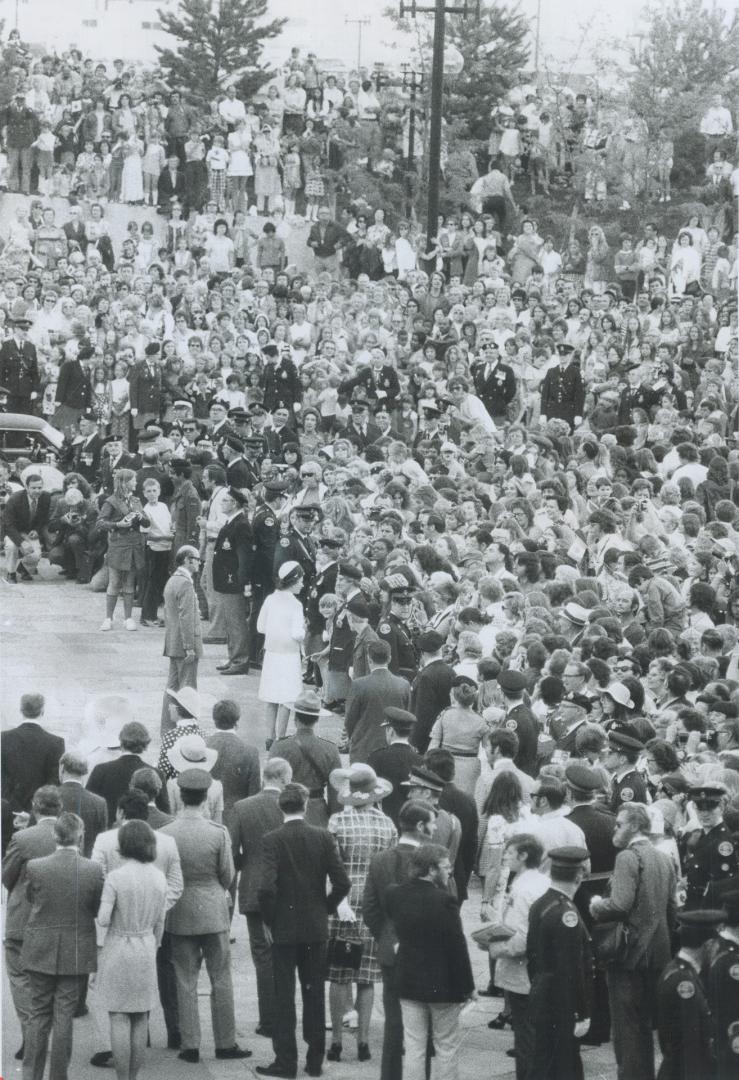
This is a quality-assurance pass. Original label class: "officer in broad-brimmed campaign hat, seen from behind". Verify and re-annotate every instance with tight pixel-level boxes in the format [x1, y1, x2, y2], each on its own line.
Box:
[269, 690, 341, 828]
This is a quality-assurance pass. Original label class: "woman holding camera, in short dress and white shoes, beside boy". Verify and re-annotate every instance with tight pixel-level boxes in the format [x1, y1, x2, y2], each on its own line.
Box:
[95, 469, 146, 632]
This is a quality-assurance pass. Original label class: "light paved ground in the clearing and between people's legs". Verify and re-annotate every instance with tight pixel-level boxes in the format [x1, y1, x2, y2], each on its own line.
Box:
[0, 580, 616, 1080]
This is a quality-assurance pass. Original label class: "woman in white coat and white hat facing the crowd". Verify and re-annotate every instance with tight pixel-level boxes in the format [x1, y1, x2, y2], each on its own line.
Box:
[257, 562, 306, 750]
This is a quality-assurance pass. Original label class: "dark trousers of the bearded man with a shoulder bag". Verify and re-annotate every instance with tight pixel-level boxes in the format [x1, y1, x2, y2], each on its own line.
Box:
[606, 968, 656, 1080]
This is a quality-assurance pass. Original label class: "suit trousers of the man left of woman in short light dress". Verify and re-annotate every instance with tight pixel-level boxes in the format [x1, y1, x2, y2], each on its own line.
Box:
[23, 971, 86, 1080]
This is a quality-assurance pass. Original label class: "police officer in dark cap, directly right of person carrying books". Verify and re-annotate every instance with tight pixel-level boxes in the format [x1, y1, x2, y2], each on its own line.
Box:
[520, 848, 593, 1080]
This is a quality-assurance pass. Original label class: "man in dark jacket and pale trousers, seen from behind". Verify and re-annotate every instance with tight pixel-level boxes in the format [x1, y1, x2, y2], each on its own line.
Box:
[386, 843, 476, 1076]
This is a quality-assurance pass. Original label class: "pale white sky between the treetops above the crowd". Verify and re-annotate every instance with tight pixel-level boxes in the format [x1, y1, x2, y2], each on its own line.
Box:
[8, 0, 739, 71]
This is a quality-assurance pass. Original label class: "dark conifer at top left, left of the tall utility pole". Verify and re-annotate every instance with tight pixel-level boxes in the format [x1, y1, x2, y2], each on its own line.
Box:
[157, 0, 286, 104]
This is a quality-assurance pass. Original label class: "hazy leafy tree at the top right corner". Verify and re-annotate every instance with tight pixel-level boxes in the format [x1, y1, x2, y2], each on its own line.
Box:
[629, 0, 739, 137]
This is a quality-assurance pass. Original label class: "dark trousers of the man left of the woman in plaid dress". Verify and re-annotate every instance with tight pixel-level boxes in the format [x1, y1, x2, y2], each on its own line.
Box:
[272, 942, 326, 1074]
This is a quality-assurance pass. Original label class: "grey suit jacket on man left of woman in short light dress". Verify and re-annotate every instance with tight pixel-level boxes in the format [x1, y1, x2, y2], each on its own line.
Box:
[21, 848, 105, 975]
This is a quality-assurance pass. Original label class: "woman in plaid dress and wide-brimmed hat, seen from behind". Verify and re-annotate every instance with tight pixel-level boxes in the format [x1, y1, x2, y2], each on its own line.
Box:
[326, 761, 398, 1062]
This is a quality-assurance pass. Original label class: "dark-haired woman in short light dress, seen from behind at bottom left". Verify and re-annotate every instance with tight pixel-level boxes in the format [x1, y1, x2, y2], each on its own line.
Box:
[96, 821, 166, 1080]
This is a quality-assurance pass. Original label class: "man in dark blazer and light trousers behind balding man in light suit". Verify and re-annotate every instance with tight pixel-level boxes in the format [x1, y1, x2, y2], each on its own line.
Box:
[213, 487, 254, 675]
